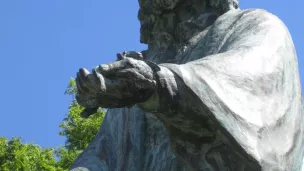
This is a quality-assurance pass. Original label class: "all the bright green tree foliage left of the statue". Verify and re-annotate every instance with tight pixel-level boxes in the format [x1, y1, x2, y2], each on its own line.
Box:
[0, 78, 105, 171]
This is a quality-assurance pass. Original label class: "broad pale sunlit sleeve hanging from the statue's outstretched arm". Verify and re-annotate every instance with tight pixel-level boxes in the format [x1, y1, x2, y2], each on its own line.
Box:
[144, 10, 303, 167]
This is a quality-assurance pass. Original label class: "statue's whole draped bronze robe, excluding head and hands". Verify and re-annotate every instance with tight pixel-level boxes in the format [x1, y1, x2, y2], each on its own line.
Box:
[72, 9, 304, 171]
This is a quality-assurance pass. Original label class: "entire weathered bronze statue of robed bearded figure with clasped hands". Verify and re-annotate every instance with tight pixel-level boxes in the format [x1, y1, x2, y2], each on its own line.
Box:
[72, 0, 304, 171]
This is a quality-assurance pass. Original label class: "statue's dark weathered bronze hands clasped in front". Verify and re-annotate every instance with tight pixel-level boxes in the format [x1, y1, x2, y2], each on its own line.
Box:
[76, 56, 156, 108]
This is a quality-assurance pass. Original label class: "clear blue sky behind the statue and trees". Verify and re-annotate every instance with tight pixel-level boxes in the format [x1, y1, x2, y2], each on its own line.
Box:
[0, 0, 304, 147]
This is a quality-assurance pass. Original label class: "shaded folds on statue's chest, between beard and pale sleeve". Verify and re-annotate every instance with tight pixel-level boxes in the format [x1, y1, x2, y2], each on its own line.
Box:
[147, 11, 242, 64]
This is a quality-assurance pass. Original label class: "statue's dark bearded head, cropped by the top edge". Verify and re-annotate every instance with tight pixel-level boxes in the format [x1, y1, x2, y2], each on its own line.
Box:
[138, 0, 238, 44]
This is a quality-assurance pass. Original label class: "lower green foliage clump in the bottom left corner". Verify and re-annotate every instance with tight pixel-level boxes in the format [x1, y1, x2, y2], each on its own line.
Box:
[0, 137, 63, 171]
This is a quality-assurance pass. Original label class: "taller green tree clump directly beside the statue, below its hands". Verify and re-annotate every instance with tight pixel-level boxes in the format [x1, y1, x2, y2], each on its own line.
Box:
[56, 79, 105, 169]
